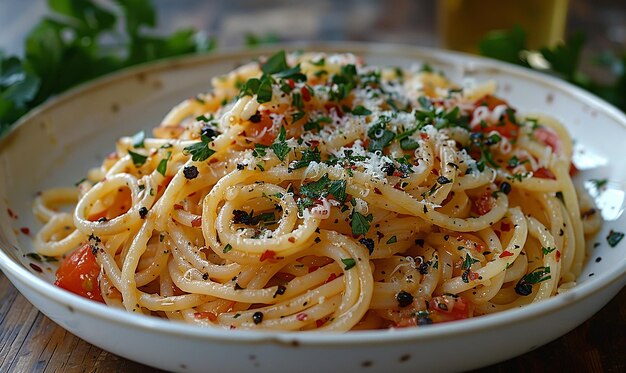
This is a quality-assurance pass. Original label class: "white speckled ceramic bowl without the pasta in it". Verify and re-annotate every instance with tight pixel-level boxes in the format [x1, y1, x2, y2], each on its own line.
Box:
[0, 44, 626, 372]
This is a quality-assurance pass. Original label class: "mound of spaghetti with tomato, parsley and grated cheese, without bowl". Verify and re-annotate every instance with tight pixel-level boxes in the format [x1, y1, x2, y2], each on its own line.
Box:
[34, 52, 601, 331]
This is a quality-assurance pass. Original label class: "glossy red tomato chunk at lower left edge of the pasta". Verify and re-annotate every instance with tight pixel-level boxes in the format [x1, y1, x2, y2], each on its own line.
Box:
[54, 244, 104, 303]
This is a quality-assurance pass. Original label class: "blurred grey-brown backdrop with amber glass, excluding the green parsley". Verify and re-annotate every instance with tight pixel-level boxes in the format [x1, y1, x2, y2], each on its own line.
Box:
[0, 0, 626, 54]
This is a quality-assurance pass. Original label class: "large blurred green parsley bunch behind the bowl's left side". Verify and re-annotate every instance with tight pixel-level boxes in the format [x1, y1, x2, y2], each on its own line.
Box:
[0, 0, 215, 134]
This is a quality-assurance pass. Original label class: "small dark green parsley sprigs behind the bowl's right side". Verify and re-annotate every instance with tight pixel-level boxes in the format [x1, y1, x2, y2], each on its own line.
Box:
[479, 27, 626, 111]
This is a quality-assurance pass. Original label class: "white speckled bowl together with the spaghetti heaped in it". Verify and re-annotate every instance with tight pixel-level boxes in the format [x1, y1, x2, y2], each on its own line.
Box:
[0, 44, 626, 371]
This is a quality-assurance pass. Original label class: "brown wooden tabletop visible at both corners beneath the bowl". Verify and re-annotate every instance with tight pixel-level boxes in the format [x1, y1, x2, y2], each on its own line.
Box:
[0, 272, 626, 373]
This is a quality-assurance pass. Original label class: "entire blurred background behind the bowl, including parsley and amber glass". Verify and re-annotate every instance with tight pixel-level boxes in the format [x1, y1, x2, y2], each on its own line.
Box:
[0, 0, 626, 127]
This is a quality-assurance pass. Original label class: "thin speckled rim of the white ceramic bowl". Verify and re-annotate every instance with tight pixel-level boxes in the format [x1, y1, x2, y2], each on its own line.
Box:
[0, 42, 626, 346]
